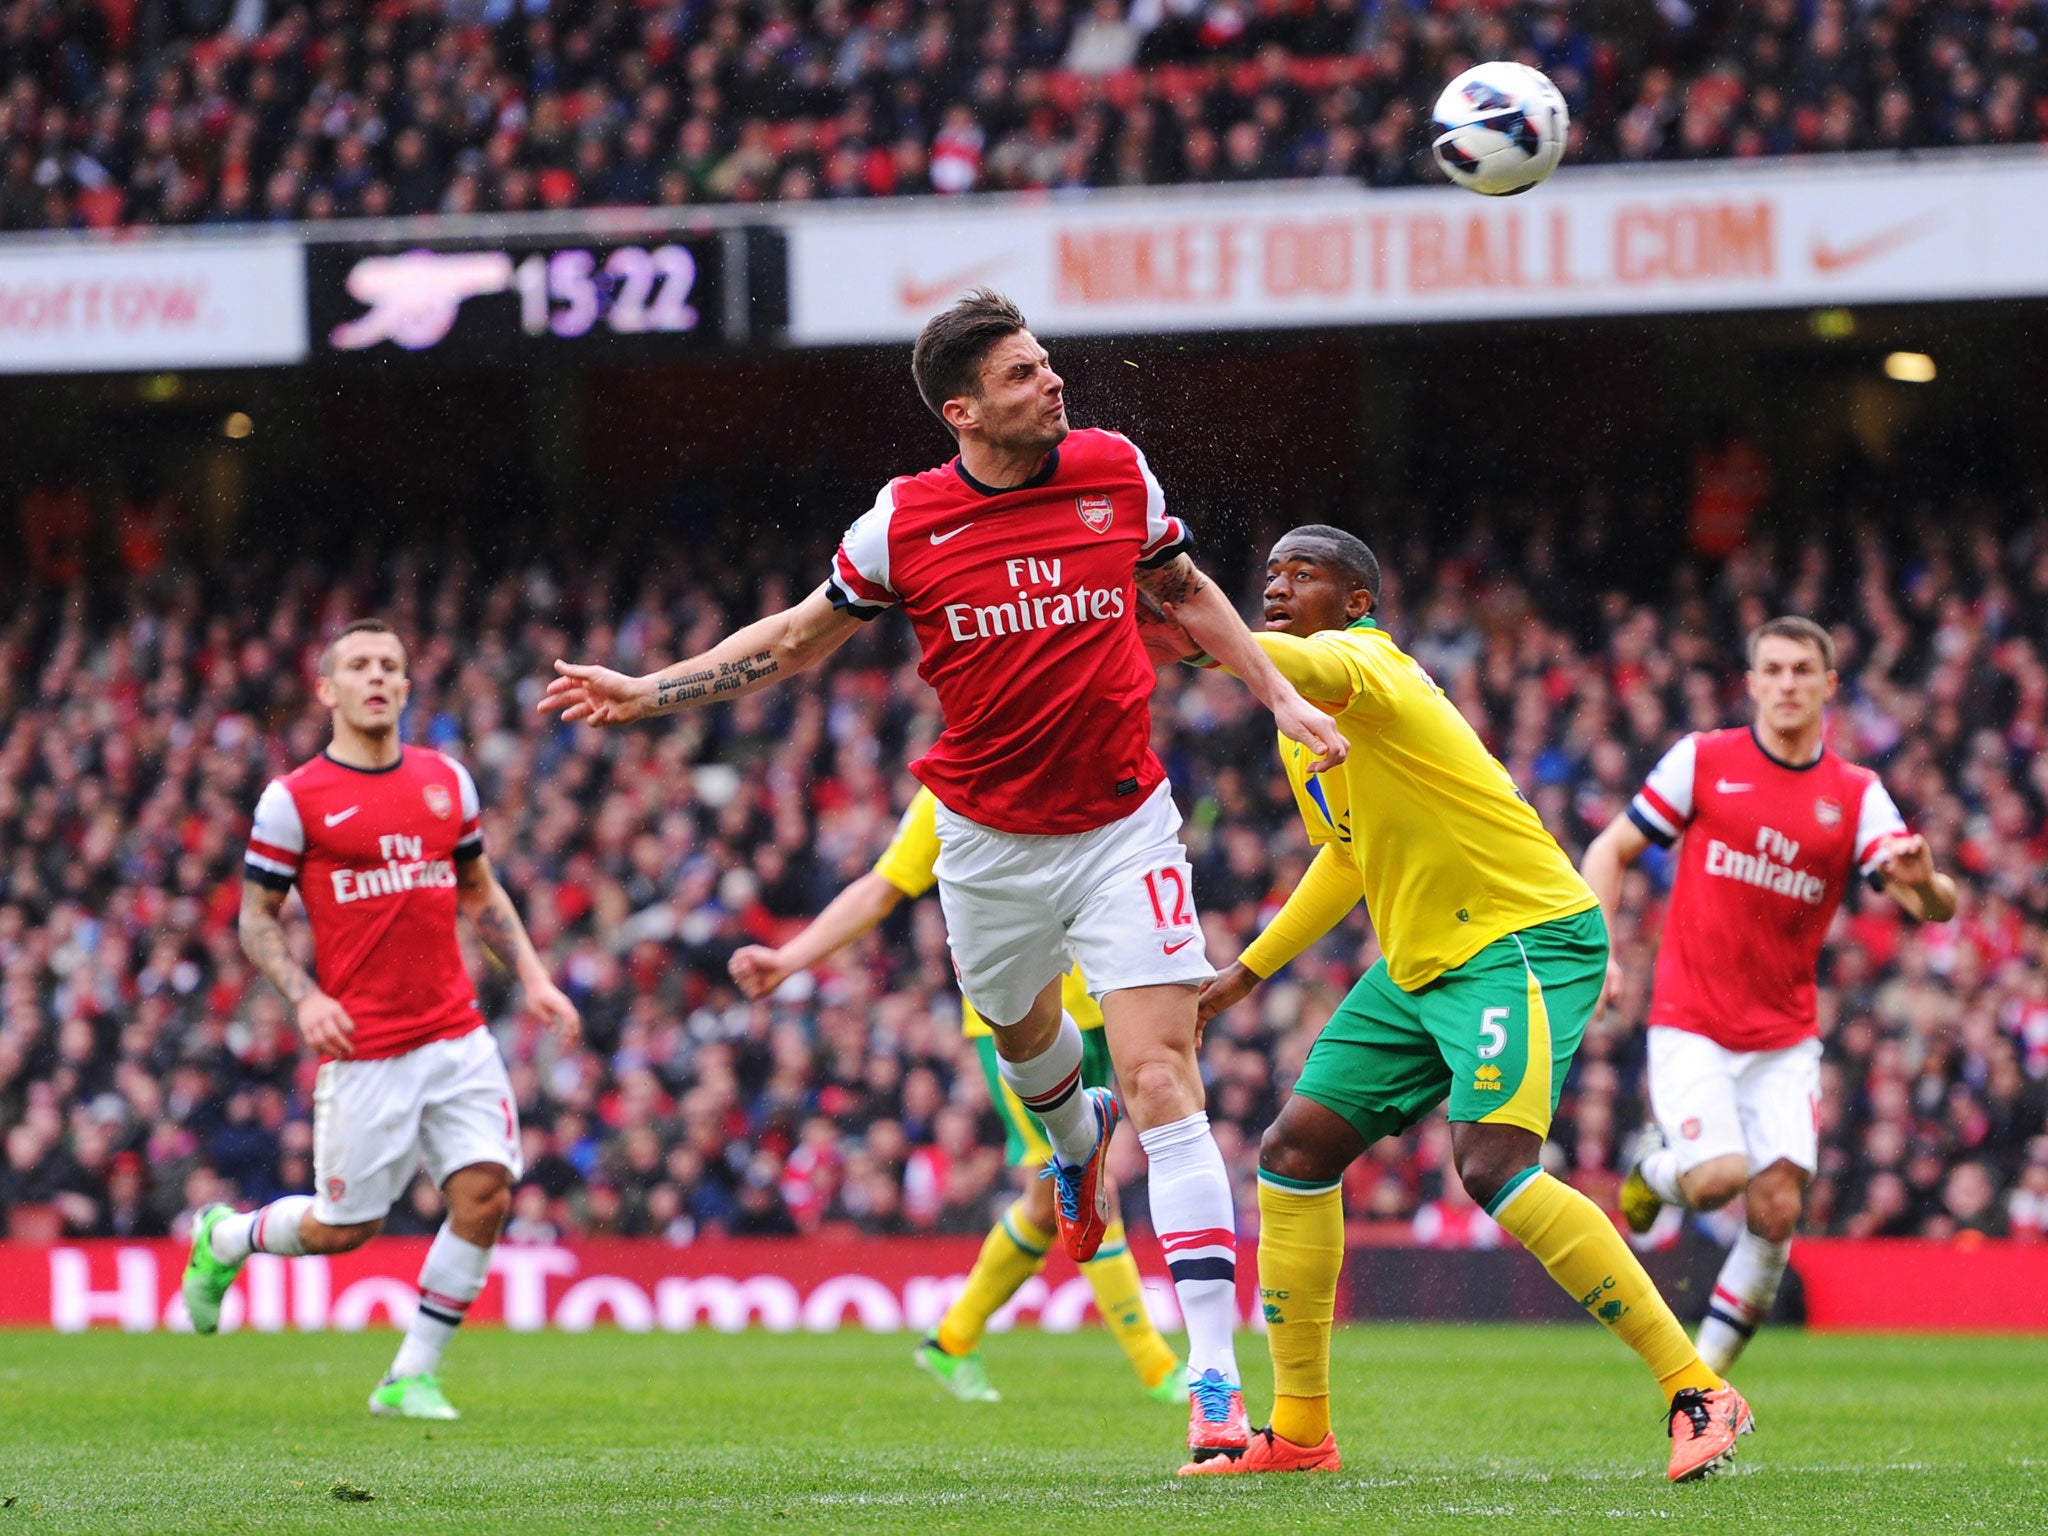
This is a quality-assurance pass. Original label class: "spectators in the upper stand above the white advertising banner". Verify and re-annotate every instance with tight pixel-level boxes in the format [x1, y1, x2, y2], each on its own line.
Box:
[0, 0, 2048, 229]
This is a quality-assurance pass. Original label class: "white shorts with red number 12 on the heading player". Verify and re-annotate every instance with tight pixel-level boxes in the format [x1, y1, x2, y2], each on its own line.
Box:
[938, 782, 1217, 1024]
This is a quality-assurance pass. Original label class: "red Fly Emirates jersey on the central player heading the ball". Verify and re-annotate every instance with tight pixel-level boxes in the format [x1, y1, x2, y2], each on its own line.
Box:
[829, 430, 1188, 836]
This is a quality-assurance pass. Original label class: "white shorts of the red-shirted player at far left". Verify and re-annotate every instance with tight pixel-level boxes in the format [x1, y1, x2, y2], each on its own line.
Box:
[313, 1026, 526, 1227]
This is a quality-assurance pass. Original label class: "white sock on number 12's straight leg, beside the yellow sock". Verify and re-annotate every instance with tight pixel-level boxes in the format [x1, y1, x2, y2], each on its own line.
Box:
[1139, 1110, 1239, 1384]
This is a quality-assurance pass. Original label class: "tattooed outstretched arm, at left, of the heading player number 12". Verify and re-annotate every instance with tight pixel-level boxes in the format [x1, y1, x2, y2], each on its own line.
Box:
[537, 586, 860, 725]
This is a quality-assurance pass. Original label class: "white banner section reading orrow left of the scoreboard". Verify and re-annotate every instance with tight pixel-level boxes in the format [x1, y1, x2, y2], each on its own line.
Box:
[0, 240, 305, 373]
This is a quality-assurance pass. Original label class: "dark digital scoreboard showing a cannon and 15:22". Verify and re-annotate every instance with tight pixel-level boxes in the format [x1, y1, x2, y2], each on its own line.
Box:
[307, 229, 782, 358]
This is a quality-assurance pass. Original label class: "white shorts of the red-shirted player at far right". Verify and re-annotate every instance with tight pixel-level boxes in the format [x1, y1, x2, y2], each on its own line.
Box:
[1649, 1024, 1821, 1176]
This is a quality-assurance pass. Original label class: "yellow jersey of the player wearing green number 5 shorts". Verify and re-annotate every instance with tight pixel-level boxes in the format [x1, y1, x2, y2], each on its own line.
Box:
[1243, 621, 1597, 991]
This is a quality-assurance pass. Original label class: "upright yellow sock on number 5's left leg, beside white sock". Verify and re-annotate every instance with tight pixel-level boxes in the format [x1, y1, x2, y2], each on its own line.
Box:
[1260, 1171, 1343, 1446]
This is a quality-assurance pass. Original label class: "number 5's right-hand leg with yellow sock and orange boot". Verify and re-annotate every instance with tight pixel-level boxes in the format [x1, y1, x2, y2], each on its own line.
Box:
[1450, 1120, 1753, 1483]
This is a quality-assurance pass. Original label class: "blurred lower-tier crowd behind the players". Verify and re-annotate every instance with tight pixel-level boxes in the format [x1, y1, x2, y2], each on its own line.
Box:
[0, 462, 2048, 1243]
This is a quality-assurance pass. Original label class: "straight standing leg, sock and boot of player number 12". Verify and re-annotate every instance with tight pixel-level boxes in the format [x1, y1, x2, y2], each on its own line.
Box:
[1102, 983, 1251, 1460]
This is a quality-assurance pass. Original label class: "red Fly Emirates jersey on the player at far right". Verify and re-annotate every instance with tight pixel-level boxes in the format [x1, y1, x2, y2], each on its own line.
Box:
[1628, 729, 1907, 1051]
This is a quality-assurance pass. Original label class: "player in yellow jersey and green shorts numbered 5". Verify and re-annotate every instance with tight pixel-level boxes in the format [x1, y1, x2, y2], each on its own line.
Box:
[1153, 524, 1751, 1481]
